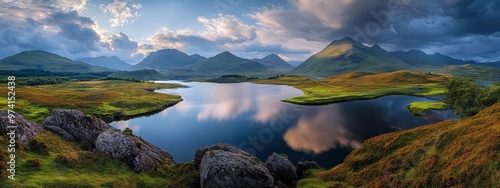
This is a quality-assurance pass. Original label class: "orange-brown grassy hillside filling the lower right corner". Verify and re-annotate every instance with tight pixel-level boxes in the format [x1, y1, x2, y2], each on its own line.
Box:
[299, 103, 500, 187]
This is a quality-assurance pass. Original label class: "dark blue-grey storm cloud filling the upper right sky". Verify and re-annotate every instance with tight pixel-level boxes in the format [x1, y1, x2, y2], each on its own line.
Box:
[252, 0, 500, 60]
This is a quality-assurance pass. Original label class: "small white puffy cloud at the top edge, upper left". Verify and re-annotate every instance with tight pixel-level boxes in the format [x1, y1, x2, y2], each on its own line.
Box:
[99, 0, 142, 27]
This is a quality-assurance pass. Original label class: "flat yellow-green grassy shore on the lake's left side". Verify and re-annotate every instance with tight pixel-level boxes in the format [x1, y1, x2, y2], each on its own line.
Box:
[0, 80, 182, 123]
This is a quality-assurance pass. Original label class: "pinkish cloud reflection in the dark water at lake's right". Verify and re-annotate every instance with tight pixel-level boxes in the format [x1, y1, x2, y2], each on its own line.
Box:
[284, 105, 361, 154]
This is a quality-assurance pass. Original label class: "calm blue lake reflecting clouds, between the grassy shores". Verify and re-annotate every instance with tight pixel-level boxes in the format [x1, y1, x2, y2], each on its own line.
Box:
[111, 82, 442, 168]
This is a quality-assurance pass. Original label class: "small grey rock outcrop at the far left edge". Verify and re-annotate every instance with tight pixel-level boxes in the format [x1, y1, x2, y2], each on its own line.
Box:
[0, 111, 43, 144]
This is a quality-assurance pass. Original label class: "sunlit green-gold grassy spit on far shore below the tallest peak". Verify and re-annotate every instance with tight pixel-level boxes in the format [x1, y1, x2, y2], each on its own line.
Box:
[255, 71, 448, 105]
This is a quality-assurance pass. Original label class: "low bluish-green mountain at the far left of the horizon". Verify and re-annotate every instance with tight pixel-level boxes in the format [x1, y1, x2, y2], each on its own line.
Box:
[0, 50, 110, 72]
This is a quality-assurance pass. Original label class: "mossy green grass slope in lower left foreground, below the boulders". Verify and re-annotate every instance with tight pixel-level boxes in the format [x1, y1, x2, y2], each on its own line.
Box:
[0, 131, 199, 188]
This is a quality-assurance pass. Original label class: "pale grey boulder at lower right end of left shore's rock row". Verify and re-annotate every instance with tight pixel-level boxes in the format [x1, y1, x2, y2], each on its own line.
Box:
[95, 127, 174, 172]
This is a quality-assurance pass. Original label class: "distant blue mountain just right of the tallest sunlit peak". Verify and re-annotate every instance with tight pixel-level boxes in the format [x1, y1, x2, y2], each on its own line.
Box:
[390, 50, 476, 68]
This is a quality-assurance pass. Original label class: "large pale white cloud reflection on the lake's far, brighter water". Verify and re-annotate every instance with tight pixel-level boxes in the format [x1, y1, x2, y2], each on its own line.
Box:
[166, 83, 300, 123]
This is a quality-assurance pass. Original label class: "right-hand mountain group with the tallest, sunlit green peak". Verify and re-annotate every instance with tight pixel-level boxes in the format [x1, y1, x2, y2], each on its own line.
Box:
[292, 37, 500, 77]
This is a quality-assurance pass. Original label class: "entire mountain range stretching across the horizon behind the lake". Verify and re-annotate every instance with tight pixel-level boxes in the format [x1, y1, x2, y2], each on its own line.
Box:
[0, 37, 500, 78]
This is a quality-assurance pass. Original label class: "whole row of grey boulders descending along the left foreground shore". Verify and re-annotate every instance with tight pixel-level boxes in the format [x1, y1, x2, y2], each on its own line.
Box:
[43, 109, 174, 172]
